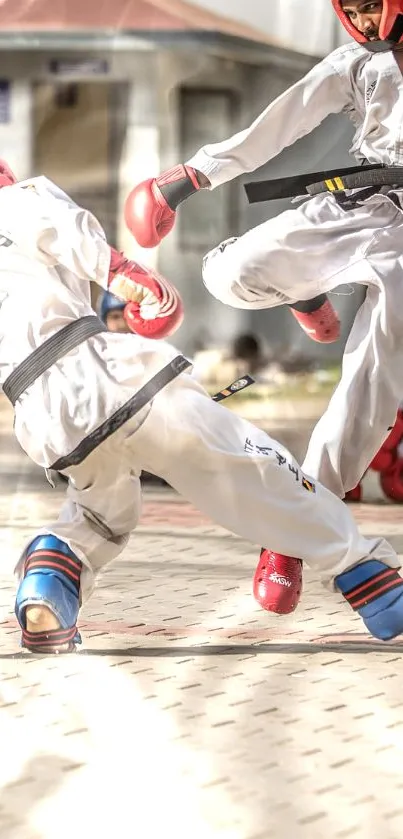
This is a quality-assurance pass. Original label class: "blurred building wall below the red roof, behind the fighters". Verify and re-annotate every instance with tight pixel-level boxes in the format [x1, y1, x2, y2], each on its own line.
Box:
[0, 33, 358, 359]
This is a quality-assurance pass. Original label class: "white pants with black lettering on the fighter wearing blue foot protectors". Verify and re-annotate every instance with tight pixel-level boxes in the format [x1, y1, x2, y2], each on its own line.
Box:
[15, 373, 400, 599]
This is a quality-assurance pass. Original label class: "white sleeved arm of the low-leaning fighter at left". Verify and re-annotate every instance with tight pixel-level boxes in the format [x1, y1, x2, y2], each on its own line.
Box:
[0, 185, 110, 288]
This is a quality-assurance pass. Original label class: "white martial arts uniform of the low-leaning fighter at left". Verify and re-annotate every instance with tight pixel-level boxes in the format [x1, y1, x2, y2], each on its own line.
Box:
[0, 178, 399, 598]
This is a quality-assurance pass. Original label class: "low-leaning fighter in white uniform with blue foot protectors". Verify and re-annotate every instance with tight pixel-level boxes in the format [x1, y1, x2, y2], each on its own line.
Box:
[0, 164, 403, 651]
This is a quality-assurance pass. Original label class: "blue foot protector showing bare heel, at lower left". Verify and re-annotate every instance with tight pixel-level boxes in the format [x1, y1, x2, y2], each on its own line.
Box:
[15, 534, 82, 652]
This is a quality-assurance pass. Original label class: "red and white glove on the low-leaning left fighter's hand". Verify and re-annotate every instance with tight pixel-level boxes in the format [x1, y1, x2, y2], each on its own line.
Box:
[108, 248, 183, 339]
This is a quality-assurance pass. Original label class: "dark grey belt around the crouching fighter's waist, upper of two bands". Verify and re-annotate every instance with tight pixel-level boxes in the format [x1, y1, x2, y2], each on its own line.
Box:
[3, 315, 106, 405]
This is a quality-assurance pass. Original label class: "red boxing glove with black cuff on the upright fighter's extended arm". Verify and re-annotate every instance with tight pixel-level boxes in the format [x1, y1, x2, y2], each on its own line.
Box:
[124, 165, 200, 248]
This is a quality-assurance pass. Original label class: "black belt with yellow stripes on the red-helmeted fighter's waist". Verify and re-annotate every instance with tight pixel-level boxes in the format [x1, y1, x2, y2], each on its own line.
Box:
[245, 164, 403, 204]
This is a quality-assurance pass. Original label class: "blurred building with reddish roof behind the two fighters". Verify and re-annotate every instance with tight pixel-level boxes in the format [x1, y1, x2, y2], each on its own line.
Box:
[0, 0, 361, 361]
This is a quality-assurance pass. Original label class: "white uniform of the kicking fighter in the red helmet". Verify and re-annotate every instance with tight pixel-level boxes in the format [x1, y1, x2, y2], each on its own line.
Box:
[187, 44, 403, 497]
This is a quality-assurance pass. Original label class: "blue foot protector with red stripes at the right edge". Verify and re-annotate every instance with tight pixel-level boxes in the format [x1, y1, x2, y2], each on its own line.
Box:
[335, 559, 403, 641]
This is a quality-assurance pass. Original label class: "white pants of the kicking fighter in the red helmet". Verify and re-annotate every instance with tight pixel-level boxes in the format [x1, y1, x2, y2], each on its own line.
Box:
[203, 193, 403, 498]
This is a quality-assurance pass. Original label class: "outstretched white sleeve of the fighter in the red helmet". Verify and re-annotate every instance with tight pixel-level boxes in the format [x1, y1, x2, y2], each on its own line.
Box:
[186, 56, 351, 188]
